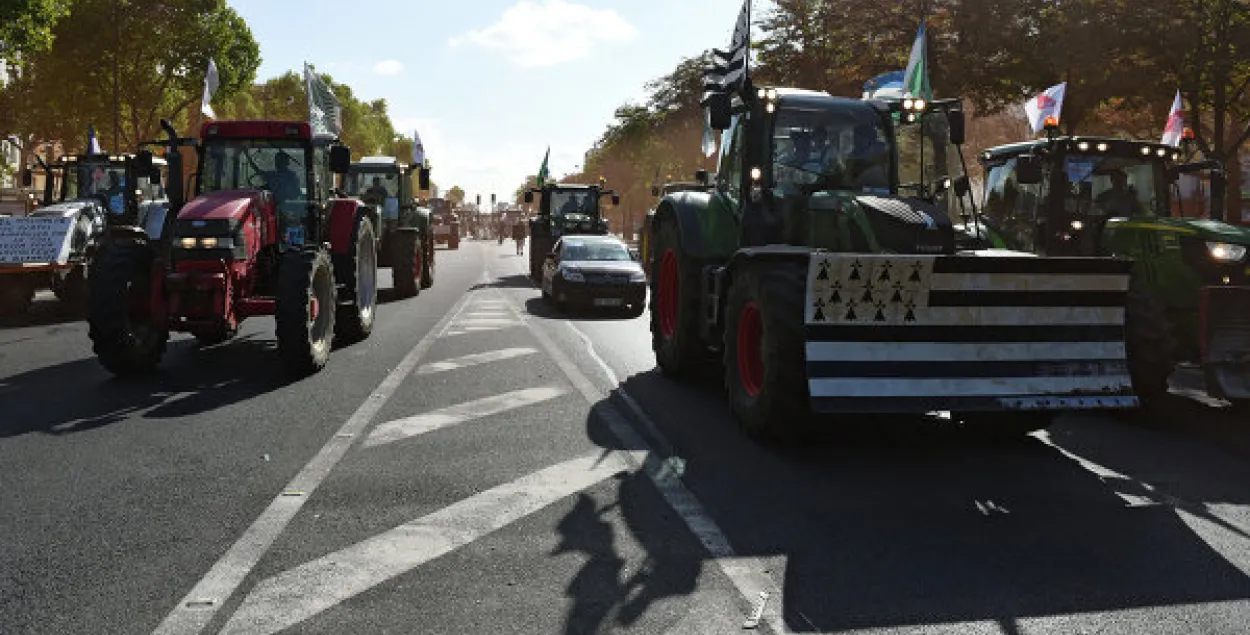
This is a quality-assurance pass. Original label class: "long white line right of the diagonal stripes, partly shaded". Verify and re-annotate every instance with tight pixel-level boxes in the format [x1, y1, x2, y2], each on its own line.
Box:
[495, 289, 800, 635]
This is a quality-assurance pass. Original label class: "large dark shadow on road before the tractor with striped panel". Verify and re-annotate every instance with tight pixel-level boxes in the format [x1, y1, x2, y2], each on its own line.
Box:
[566, 371, 1250, 633]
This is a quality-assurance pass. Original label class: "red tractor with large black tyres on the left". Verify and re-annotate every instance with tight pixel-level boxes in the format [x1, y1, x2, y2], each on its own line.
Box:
[88, 121, 378, 376]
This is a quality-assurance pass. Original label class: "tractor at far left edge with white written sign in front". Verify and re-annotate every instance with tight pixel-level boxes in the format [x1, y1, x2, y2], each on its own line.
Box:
[0, 154, 168, 315]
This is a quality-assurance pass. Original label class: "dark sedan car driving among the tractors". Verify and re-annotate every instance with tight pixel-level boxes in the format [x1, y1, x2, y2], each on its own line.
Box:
[543, 236, 646, 316]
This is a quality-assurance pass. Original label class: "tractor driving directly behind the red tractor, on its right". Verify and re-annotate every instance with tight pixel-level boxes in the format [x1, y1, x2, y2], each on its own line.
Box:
[343, 156, 434, 298]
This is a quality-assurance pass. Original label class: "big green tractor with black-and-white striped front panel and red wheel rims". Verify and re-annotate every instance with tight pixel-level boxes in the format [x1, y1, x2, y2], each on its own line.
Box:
[649, 80, 1138, 439]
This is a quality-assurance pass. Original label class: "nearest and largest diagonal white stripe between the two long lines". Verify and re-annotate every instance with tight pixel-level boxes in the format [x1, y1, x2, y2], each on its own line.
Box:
[220, 453, 640, 635]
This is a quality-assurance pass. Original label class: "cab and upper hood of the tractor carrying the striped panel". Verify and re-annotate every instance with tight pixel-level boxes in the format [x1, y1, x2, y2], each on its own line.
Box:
[711, 88, 968, 254]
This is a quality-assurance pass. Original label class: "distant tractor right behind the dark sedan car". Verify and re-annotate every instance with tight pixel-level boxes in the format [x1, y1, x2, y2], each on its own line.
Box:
[525, 180, 621, 277]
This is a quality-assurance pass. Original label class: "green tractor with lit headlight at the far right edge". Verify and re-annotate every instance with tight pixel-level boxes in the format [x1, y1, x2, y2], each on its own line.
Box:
[966, 129, 1250, 408]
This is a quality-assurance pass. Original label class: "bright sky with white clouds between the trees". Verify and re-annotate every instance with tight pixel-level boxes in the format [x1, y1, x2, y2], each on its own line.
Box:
[229, 0, 750, 203]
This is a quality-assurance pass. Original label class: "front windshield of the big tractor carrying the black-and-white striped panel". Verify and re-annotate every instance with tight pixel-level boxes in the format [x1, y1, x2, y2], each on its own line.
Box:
[773, 106, 890, 191]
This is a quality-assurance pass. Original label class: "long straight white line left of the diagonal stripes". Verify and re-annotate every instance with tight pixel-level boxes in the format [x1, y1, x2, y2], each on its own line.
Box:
[153, 266, 485, 635]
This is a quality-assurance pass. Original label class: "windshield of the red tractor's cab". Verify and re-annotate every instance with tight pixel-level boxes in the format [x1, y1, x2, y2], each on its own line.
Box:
[199, 139, 309, 205]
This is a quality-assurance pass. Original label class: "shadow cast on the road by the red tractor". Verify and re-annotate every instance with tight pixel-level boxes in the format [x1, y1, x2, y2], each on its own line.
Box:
[0, 338, 291, 439]
